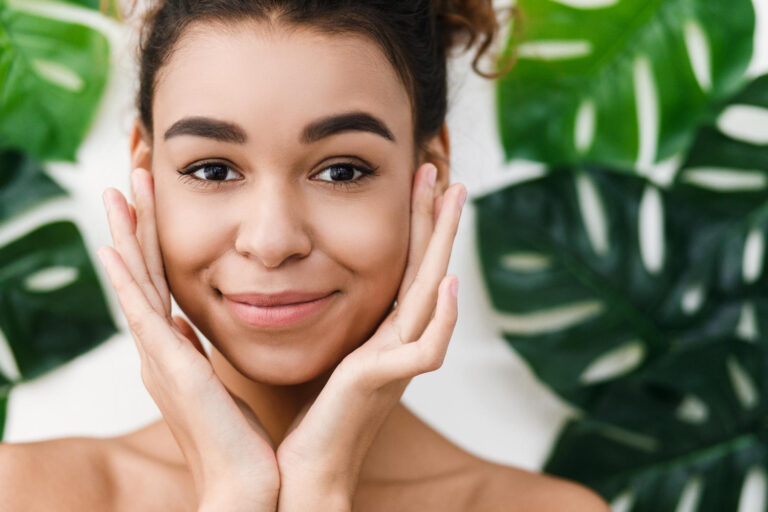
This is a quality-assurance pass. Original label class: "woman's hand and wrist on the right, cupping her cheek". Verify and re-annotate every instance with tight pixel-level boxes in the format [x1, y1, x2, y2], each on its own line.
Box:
[276, 164, 466, 512]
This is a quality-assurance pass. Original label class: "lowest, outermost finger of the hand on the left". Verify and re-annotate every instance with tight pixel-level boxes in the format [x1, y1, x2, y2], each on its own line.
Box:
[96, 246, 176, 360]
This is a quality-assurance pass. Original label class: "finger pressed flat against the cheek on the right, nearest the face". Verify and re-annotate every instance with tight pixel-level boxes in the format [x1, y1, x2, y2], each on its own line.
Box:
[397, 163, 437, 303]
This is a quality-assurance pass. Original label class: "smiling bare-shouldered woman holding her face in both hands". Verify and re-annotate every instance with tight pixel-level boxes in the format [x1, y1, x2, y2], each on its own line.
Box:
[0, 0, 608, 512]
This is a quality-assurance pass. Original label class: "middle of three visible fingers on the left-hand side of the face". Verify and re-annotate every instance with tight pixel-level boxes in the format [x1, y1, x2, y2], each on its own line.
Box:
[103, 188, 166, 315]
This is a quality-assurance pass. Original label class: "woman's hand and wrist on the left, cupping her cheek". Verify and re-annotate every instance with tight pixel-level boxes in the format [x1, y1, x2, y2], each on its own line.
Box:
[98, 169, 280, 512]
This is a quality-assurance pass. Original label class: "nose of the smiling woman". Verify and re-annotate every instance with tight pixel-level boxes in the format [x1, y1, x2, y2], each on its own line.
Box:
[235, 180, 312, 268]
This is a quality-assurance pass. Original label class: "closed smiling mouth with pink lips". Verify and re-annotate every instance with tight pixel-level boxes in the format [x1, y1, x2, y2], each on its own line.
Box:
[222, 290, 338, 329]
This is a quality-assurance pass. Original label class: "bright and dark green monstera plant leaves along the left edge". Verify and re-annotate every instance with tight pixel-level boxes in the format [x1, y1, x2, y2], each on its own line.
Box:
[0, 0, 116, 439]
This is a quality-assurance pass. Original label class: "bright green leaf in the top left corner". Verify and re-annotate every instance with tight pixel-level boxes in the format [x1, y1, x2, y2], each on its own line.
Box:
[0, 1, 109, 160]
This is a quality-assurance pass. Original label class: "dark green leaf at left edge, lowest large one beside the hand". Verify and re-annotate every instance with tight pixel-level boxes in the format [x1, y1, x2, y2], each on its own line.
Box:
[0, 221, 116, 380]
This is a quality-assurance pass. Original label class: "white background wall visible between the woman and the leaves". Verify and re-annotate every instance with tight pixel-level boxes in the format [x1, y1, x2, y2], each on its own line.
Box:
[0, 0, 768, 500]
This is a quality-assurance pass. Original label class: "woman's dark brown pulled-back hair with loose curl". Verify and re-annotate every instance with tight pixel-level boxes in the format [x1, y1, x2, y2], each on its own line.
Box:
[121, 0, 511, 161]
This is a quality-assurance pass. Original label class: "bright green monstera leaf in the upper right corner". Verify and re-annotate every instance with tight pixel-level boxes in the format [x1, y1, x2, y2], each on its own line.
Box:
[497, 0, 755, 172]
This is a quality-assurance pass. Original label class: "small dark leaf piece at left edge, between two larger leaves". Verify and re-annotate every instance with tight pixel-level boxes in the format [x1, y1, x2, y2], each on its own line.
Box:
[0, 150, 66, 222]
